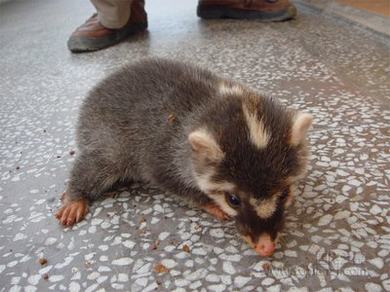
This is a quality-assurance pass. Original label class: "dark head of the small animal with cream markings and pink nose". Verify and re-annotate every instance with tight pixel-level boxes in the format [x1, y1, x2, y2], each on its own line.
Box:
[188, 86, 312, 256]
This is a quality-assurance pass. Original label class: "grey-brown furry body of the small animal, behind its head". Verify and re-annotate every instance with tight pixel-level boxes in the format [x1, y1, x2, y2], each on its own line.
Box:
[67, 60, 218, 205]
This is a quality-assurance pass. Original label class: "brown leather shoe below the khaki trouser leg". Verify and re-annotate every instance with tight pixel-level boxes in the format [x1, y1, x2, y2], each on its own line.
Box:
[68, 0, 148, 53]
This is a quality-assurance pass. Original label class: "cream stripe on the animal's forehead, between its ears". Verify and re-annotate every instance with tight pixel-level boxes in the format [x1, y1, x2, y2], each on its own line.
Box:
[242, 105, 269, 148]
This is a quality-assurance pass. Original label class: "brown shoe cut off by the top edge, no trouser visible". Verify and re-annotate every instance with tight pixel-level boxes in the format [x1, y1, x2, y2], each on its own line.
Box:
[197, 0, 297, 21]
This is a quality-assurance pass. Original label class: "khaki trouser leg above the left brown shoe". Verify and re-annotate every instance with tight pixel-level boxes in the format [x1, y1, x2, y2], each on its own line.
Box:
[91, 0, 132, 29]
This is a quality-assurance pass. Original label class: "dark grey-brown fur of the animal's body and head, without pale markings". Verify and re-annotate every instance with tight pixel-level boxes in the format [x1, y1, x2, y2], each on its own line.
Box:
[67, 59, 307, 245]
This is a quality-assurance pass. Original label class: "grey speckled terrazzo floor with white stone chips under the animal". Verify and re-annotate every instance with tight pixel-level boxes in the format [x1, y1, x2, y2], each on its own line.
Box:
[0, 0, 390, 291]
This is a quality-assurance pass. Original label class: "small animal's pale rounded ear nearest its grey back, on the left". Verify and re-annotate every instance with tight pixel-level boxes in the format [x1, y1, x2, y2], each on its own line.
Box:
[188, 129, 224, 161]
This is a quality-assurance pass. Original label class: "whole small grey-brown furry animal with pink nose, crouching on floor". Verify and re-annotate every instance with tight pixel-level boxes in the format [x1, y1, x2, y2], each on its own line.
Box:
[56, 59, 312, 256]
